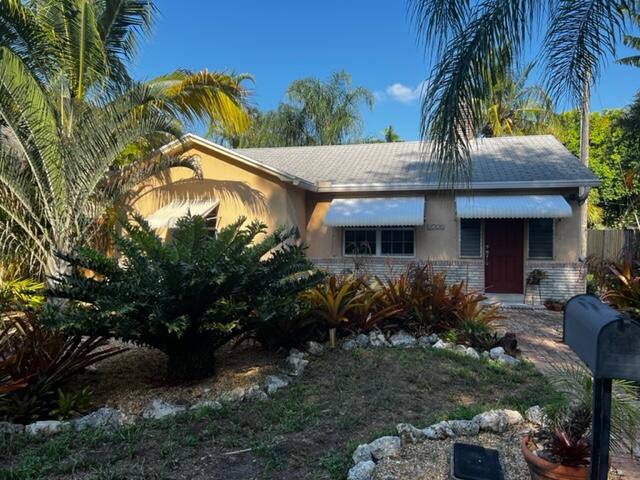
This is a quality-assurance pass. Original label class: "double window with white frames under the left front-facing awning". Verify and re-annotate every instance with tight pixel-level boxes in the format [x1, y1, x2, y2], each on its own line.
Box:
[344, 228, 415, 256]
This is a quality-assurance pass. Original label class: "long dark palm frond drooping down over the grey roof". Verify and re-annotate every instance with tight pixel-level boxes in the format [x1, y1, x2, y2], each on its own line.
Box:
[420, 0, 540, 185]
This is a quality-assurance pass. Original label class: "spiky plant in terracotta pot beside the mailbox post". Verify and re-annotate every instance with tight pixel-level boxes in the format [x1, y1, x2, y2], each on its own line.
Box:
[520, 366, 640, 480]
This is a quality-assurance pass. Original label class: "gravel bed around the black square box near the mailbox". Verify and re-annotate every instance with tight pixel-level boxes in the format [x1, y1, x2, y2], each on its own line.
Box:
[373, 428, 626, 480]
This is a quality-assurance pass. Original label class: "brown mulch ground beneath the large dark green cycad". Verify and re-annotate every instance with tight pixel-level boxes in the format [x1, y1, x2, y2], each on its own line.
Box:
[74, 342, 284, 414]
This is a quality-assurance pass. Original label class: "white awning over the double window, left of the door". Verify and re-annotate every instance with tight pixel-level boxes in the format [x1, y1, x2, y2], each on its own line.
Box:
[324, 197, 424, 227]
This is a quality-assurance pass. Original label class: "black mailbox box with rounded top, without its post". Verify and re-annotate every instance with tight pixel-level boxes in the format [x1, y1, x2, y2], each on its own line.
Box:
[564, 295, 640, 380]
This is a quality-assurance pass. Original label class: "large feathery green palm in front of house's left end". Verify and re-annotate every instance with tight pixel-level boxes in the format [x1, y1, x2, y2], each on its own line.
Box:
[0, 47, 194, 275]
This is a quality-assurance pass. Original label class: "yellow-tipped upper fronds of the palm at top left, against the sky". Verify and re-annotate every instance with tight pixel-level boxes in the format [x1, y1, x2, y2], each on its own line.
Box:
[0, 0, 250, 133]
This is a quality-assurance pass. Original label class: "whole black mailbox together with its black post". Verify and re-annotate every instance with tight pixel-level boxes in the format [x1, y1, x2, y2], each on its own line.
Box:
[563, 295, 640, 480]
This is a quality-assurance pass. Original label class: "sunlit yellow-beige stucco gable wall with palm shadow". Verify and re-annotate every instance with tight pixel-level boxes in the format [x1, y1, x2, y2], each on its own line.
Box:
[133, 143, 306, 236]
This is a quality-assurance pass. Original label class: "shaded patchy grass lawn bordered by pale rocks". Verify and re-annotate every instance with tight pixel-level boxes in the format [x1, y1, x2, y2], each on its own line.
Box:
[0, 348, 554, 480]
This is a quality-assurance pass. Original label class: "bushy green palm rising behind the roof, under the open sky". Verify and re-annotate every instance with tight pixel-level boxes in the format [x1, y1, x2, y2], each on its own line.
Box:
[287, 70, 374, 145]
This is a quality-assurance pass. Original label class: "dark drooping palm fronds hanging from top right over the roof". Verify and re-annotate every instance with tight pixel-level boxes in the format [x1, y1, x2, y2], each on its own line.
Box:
[410, 0, 638, 182]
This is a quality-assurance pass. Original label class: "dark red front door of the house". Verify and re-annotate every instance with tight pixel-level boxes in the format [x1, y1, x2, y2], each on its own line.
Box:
[484, 220, 524, 293]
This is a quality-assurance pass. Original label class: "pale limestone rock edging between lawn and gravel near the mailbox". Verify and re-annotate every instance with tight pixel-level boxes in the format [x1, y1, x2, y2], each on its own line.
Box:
[347, 406, 528, 474]
